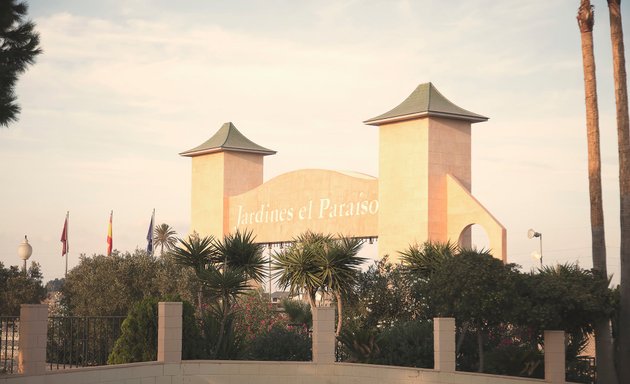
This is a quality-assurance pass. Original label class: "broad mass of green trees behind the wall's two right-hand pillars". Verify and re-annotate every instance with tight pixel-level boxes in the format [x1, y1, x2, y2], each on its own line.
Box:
[339, 243, 618, 381]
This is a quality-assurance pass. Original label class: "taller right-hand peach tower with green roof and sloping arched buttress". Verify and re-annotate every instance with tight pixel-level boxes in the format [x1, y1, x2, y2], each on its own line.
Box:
[365, 83, 506, 260]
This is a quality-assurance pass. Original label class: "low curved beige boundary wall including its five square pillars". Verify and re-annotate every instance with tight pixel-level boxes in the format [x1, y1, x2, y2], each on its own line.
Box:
[0, 303, 565, 384]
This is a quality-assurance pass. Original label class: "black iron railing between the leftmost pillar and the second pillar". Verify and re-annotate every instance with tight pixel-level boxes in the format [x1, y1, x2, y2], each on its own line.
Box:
[46, 316, 125, 369]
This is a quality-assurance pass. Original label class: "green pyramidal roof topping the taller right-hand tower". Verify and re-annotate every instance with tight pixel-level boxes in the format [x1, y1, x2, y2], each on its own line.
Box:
[364, 83, 488, 125]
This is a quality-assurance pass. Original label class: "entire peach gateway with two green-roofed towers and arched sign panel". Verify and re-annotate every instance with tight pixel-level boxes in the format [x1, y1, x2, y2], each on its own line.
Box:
[180, 83, 507, 261]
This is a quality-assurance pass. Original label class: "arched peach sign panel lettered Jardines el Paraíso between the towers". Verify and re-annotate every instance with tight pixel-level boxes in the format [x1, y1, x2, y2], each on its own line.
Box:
[228, 169, 380, 243]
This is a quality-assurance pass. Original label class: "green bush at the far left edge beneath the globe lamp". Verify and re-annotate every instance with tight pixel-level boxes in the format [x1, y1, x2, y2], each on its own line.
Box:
[0, 262, 46, 316]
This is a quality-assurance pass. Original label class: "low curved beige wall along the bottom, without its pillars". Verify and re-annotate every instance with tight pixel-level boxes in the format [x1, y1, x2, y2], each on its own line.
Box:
[0, 360, 564, 384]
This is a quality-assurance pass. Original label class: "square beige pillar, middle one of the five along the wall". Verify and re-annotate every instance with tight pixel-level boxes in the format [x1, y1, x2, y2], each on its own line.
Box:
[313, 307, 336, 364]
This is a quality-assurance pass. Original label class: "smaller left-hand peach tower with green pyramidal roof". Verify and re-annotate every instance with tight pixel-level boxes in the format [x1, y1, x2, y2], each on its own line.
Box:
[180, 122, 276, 238]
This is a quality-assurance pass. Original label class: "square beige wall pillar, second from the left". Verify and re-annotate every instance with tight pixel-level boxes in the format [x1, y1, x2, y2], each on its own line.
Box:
[157, 302, 183, 363]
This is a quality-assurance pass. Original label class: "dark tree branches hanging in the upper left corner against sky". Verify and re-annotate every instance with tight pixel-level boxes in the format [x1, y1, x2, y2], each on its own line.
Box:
[0, 0, 42, 127]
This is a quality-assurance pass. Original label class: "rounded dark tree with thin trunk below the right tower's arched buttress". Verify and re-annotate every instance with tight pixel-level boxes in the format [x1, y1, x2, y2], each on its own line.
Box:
[403, 243, 519, 372]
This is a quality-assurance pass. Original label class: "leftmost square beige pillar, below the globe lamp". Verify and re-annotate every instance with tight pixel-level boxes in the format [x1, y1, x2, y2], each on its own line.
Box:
[18, 304, 48, 375]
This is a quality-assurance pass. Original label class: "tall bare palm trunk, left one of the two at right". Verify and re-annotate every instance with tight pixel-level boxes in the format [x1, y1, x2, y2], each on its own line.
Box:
[577, 0, 617, 383]
